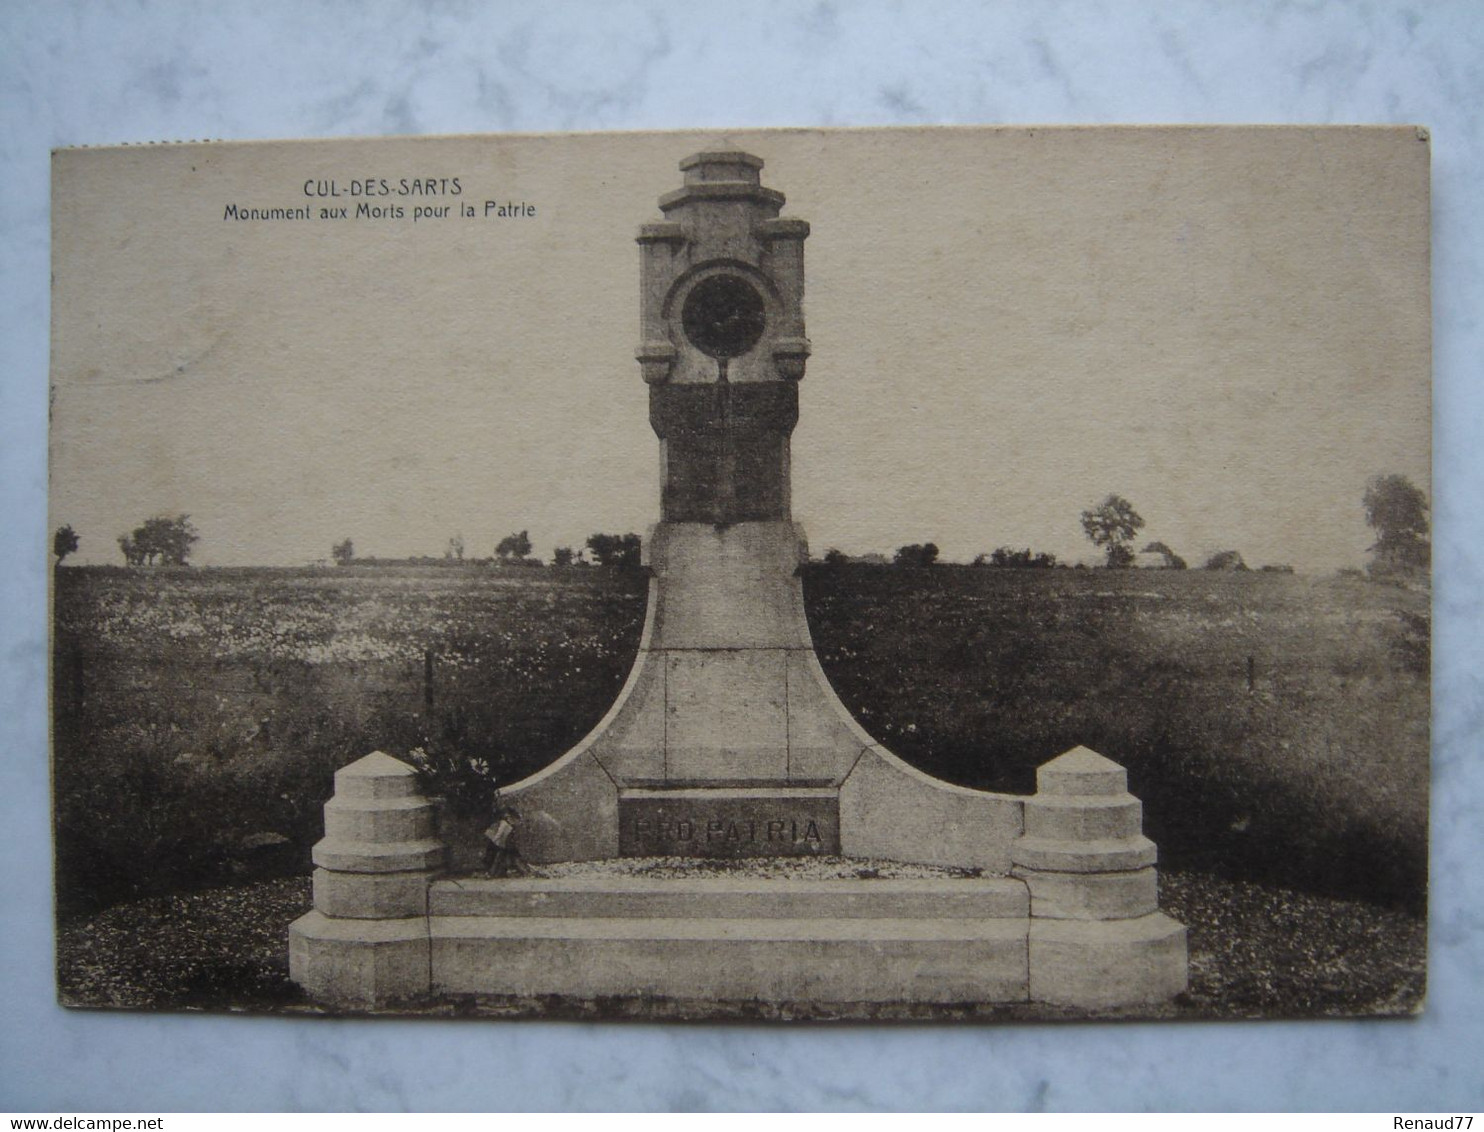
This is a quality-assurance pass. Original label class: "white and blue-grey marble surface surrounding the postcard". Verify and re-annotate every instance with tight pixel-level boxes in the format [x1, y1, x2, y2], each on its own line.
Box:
[0, 0, 1484, 1111]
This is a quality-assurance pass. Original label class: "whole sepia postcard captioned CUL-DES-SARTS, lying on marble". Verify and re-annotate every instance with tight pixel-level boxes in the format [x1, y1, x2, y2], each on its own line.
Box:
[50, 128, 1431, 1021]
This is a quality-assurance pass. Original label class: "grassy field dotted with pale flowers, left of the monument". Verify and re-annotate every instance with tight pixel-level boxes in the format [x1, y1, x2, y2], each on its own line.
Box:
[53, 567, 644, 915]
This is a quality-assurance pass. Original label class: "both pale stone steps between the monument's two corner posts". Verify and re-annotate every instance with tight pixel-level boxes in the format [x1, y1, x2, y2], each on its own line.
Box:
[429, 874, 1030, 1003]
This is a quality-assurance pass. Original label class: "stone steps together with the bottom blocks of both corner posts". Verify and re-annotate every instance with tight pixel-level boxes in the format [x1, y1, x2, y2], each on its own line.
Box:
[291, 869, 1186, 1012]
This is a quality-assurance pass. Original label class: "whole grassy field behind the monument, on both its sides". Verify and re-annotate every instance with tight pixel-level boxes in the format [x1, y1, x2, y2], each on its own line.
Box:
[55, 565, 1429, 918]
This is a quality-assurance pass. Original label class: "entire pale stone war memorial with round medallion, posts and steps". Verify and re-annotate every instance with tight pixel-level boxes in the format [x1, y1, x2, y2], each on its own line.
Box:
[289, 151, 1186, 1016]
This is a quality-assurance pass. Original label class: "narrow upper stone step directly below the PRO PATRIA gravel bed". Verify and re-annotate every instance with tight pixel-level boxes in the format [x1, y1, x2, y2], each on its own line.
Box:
[429, 875, 1030, 930]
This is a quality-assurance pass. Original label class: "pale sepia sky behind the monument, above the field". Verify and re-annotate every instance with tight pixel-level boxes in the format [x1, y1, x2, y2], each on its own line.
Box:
[50, 128, 1431, 571]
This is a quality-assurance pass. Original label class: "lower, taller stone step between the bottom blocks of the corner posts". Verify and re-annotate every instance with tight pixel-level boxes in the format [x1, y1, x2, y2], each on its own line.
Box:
[430, 915, 1028, 1003]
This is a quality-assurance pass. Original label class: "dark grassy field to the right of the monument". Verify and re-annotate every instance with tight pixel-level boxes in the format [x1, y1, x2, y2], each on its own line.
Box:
[807, 567, 1429, 912]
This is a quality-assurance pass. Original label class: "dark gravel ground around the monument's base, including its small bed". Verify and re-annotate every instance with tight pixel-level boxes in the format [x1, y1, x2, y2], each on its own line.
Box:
[56, 858, 1426, 1019]
